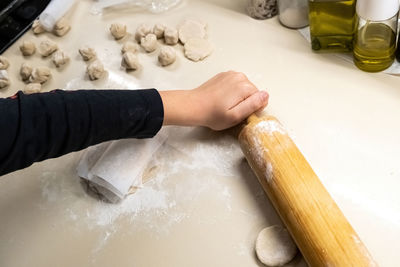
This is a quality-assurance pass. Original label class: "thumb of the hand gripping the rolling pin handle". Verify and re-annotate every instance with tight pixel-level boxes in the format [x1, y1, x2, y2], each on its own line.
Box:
[229, 91, 269, 124]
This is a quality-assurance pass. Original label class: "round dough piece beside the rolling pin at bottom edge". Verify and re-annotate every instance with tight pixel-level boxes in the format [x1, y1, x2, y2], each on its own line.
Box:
[256, 225, 297, 266]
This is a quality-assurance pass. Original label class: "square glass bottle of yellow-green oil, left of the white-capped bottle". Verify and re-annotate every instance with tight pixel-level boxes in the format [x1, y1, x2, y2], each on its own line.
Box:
[308, 0, 356, 52]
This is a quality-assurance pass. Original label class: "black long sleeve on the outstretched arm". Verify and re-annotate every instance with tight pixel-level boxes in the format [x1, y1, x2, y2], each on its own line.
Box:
[0, 89, 164, 175]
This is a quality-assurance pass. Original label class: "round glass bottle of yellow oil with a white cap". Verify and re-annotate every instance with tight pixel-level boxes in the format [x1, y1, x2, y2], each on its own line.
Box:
[353, 0, 399, 72]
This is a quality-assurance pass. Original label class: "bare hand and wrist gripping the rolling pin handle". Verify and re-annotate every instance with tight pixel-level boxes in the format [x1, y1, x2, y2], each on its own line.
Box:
[160, 71, 268, 130]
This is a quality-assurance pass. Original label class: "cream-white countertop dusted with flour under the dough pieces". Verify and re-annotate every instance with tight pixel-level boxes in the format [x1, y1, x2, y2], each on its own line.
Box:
[0, 0, 400, 267]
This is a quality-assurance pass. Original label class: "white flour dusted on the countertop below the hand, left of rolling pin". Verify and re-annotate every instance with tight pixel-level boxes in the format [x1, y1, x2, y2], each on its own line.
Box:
[40, 128, 243, 253]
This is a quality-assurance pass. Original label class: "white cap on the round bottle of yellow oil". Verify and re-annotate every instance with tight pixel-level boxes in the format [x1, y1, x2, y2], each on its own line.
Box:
[356, 0, 399, 21]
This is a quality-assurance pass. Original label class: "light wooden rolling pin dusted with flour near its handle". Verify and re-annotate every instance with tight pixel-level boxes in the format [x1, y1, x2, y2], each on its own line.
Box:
[239, 115, 378, 267]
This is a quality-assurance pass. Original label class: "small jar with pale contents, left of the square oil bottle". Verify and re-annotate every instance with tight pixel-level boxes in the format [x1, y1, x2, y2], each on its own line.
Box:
[278, 0, 308, 29]
